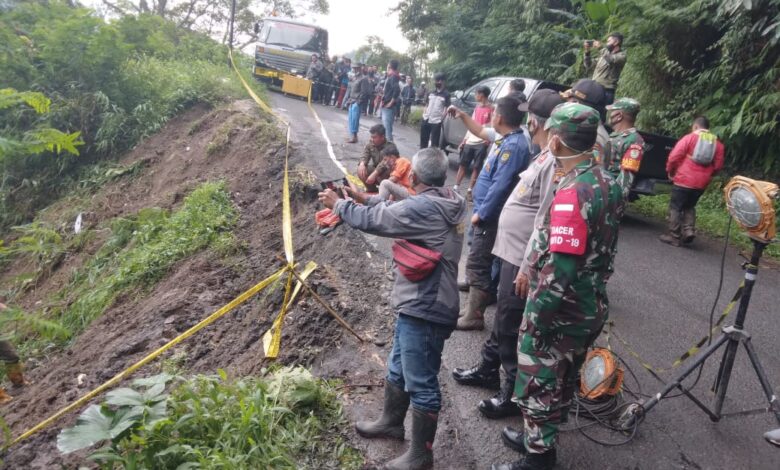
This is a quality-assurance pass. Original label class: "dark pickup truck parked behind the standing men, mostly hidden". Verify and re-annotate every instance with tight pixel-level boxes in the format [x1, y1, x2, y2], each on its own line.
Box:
[439, 77, 676, 200]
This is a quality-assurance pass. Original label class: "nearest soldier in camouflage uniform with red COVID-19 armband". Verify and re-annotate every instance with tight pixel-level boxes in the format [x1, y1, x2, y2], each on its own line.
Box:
[493, 103, 625, 470]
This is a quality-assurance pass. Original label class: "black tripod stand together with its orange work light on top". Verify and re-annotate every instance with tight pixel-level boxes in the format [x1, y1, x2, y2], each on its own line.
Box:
[620, 176, 780, 429]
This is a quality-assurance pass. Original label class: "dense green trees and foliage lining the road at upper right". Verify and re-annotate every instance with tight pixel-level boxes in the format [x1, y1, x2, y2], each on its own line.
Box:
[397, 0, 780, 179]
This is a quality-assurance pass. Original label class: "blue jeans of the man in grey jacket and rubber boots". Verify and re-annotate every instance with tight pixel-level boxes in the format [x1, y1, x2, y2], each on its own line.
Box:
[387, 314, 452, 413]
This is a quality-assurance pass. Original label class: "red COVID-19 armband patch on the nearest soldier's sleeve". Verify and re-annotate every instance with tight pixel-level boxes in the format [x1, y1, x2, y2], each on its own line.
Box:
[550, 188, 588, 255]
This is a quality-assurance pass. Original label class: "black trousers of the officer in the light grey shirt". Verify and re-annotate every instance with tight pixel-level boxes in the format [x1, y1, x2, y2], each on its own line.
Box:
[482, 259, 525, 387]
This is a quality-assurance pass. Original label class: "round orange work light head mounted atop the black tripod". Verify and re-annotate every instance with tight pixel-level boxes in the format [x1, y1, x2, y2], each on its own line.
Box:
[723, 176, 780, 243]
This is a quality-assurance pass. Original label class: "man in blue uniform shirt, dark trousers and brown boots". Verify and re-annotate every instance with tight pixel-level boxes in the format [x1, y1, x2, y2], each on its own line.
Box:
[451, 96, 530, 330]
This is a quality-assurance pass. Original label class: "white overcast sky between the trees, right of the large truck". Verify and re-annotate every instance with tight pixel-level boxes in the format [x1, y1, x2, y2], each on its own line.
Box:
[305, 0, 409, 55]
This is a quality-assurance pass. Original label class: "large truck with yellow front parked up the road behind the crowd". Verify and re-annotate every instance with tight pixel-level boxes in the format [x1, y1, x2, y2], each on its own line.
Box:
[252, 17, 328, 87]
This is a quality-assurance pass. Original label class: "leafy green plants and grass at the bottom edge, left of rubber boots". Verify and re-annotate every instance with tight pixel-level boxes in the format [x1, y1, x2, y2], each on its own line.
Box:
[58, 368, 362, 469]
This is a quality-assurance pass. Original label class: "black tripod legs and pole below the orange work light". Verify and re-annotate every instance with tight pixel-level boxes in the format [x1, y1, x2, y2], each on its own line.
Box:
[621, 240, 780, 429]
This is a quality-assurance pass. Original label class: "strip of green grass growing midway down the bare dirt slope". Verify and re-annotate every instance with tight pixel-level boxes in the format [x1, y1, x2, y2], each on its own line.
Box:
[13, 183, 240, 356]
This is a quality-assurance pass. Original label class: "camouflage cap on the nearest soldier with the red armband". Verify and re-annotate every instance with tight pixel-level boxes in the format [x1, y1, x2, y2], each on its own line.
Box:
[544, 103, 601, 151]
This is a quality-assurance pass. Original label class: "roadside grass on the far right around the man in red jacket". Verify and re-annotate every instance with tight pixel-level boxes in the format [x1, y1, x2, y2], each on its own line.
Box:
[629, 179, 780, 260]
